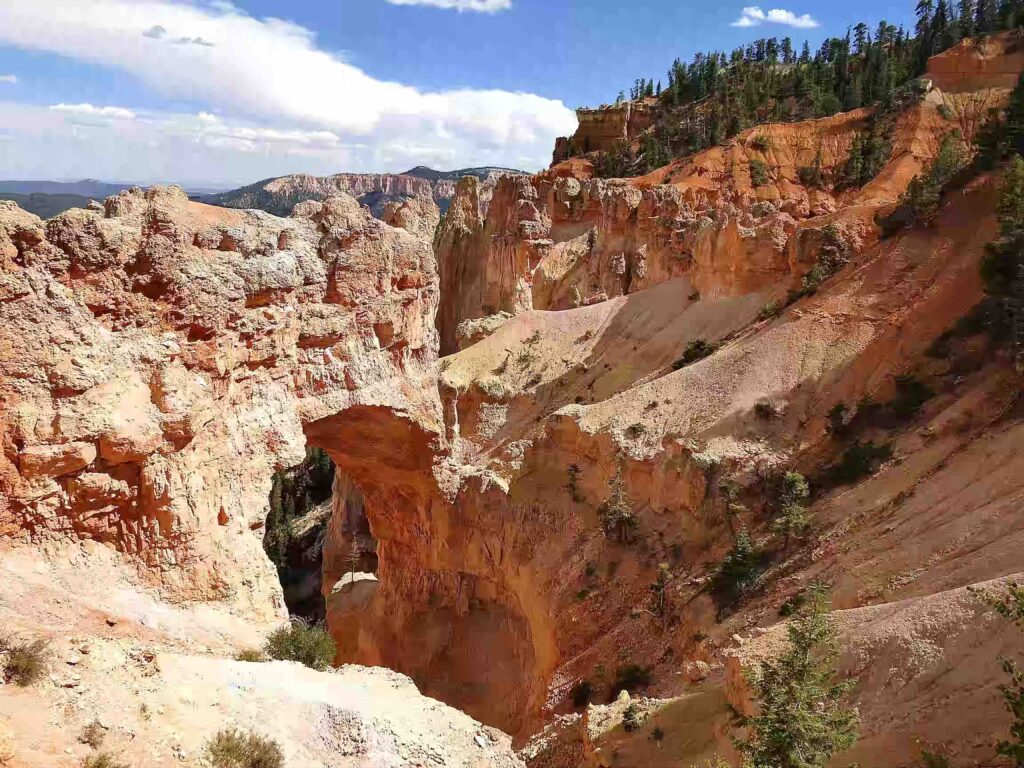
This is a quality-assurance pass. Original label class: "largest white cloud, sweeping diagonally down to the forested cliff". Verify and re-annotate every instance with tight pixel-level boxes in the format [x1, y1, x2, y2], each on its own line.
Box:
[0, 0, 575, 182]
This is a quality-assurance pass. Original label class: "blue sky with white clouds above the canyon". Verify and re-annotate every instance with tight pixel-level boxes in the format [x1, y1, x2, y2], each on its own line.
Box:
[0, 0, 913, 187]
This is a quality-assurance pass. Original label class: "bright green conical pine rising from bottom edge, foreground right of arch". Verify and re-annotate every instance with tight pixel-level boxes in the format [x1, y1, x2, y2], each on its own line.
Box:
[736, 585, 859, 768]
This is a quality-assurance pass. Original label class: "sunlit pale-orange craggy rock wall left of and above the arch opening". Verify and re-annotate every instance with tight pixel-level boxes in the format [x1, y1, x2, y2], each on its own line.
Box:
[0, 188, 437, 615]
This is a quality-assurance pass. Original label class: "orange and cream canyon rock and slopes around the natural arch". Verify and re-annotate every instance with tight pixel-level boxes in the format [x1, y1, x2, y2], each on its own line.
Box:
[0, 33, 1024, 768]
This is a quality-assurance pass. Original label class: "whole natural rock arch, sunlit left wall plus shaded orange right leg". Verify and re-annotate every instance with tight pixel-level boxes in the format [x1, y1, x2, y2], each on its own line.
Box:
[0, 188, 554, 731]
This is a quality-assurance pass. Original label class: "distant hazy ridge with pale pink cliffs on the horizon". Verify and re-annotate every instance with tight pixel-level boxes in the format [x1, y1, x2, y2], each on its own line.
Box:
[197, 166, 526, 216]
